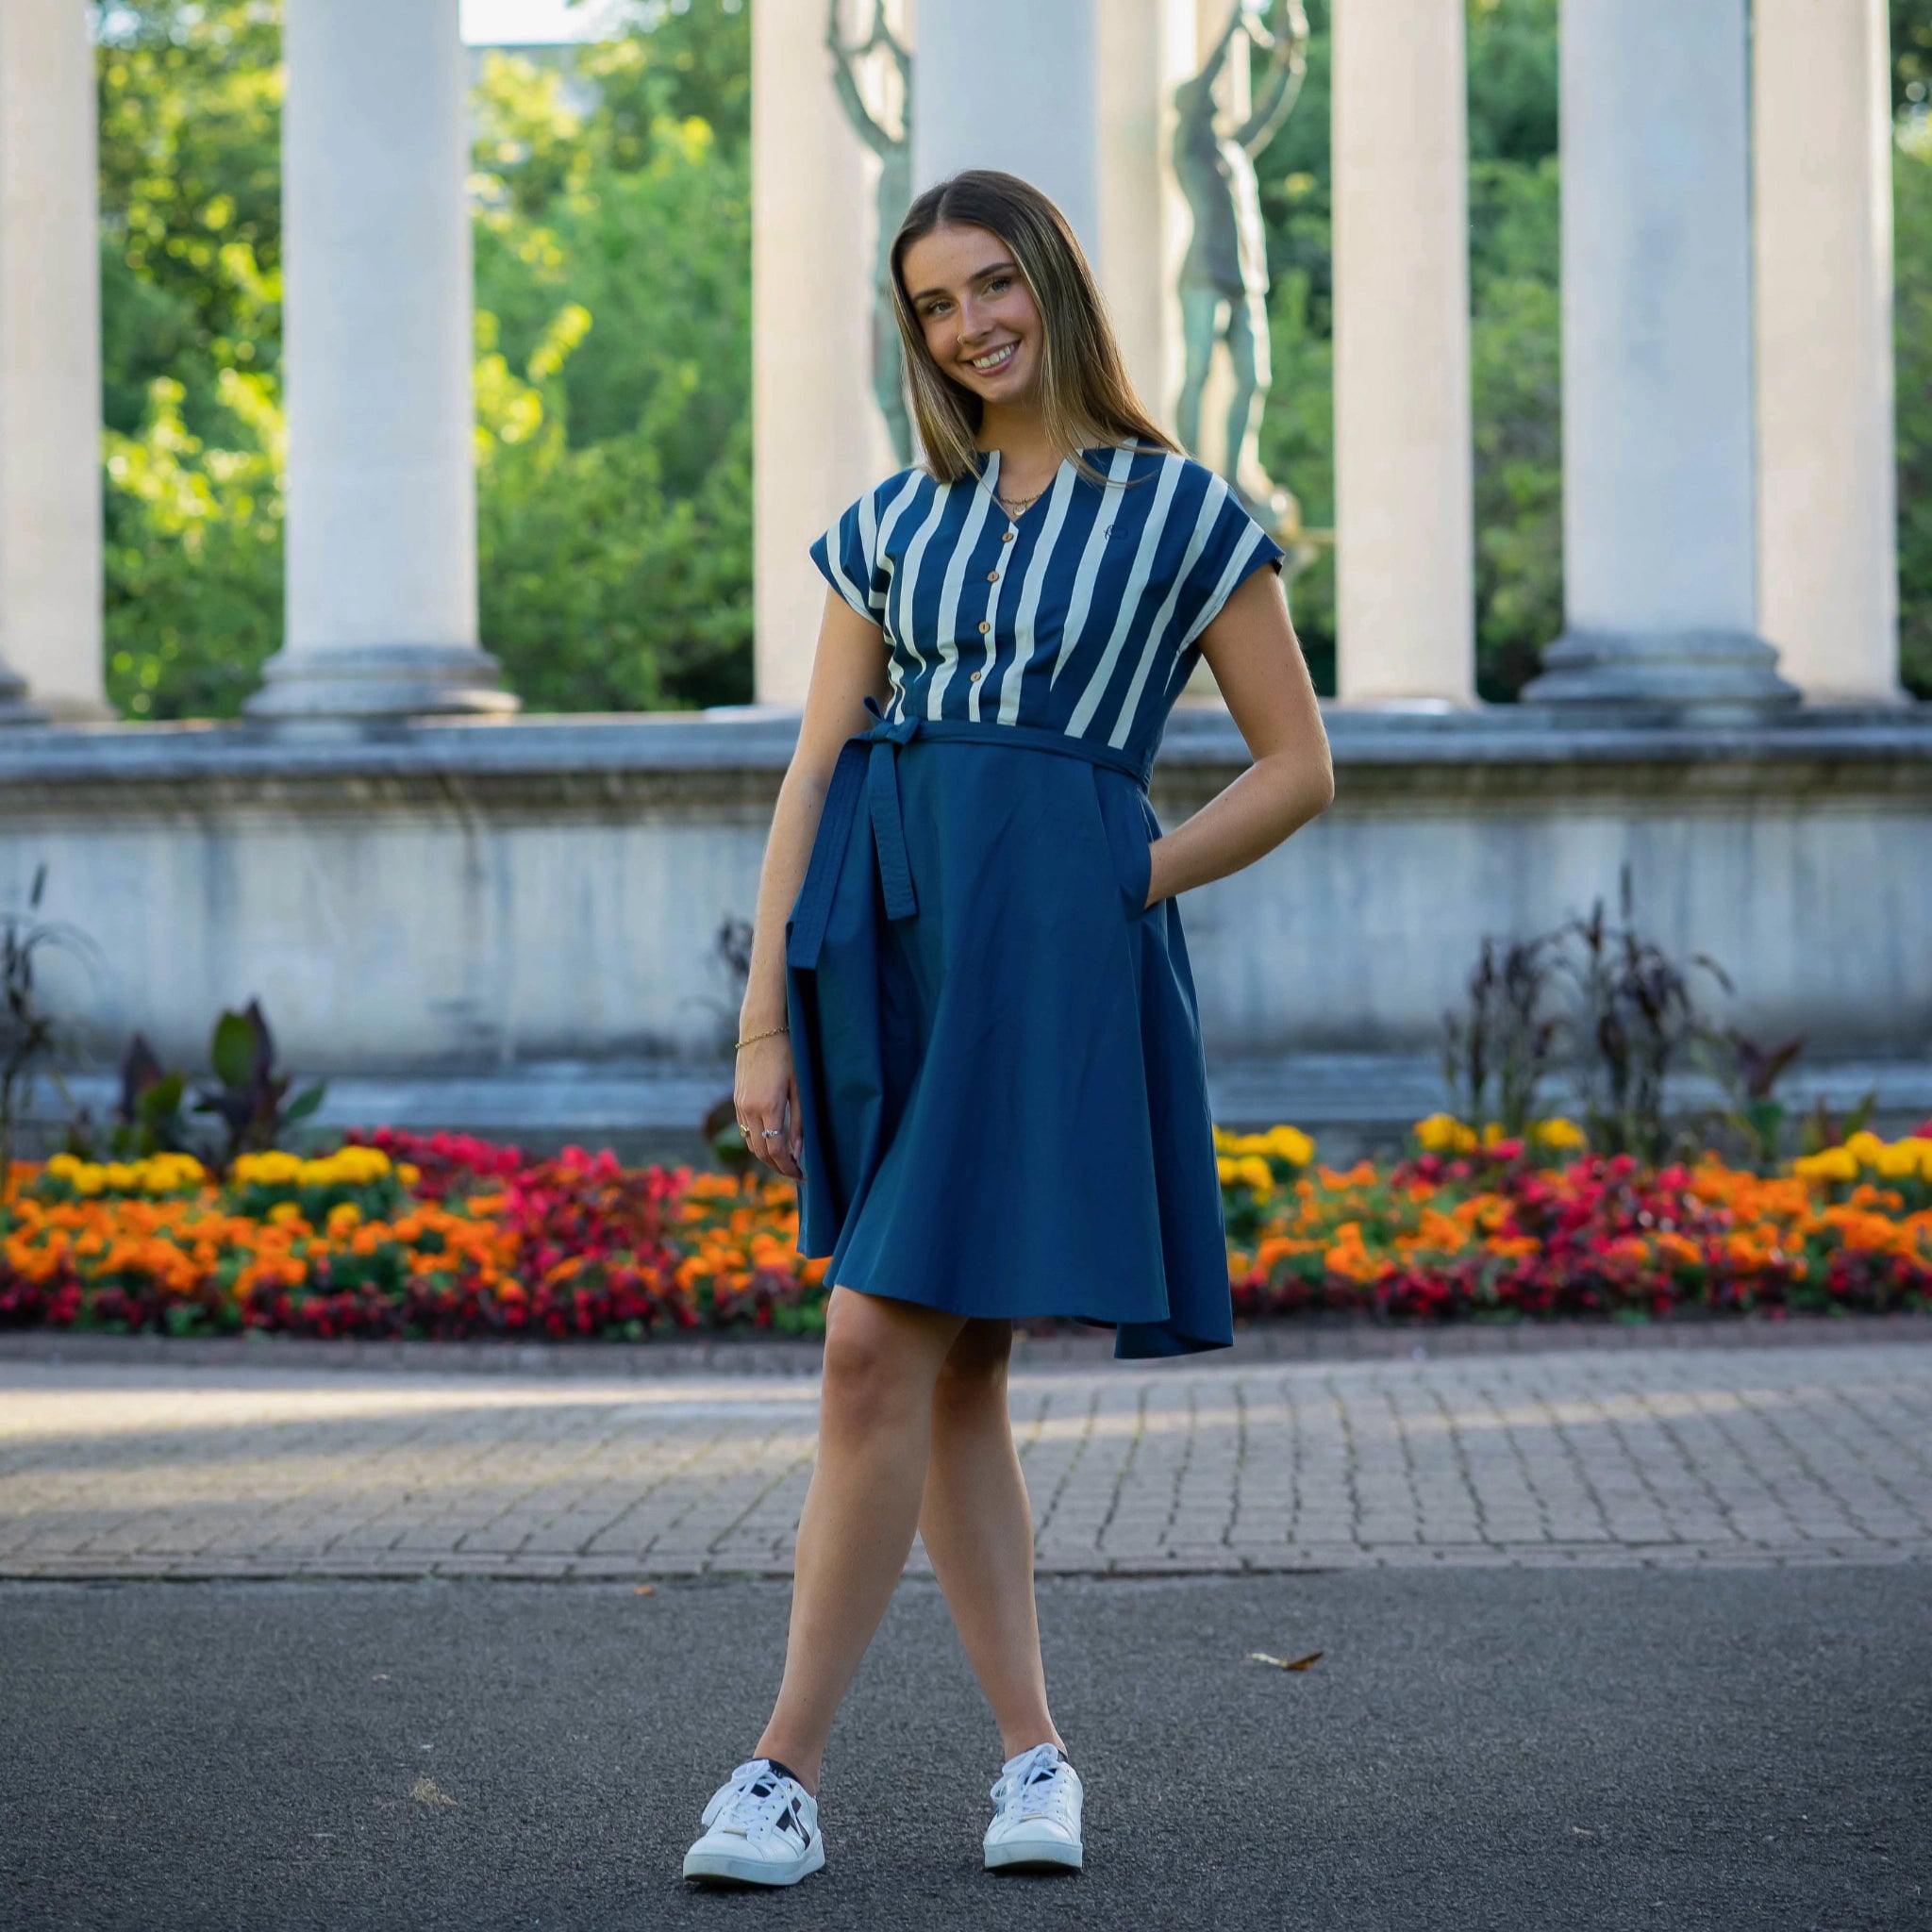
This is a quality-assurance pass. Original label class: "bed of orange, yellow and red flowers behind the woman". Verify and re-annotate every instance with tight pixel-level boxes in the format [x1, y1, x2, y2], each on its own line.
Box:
[0, 1117, 1932, 1341]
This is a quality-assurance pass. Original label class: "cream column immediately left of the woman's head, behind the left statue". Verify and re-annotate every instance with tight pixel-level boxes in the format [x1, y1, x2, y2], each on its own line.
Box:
[752, 0, 896, 706]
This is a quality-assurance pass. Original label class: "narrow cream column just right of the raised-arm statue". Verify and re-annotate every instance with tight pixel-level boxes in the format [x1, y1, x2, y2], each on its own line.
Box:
[1331, 0, 1476, 709]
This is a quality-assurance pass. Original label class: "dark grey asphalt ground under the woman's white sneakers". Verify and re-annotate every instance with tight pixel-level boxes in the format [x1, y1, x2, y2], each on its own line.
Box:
[0, 1565, 1932, 1932]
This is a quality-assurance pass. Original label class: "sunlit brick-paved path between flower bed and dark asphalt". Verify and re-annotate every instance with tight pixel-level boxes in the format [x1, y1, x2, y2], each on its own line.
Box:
[0, 1342, 1932, 1576]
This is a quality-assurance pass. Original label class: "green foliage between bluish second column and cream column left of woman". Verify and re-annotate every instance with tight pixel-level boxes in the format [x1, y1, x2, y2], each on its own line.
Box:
[477, 35, 752, 711]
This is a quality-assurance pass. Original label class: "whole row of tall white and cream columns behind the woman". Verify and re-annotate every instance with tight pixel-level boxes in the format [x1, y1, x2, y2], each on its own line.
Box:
[0, 0, 1899, 723]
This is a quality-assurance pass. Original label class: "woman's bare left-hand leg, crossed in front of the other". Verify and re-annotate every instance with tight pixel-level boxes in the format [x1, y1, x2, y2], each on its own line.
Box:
[754, 1287, 964, 1797]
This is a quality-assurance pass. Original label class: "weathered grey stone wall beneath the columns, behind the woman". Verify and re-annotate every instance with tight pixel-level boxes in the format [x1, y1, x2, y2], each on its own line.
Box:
[0, 703, 1932, 1132]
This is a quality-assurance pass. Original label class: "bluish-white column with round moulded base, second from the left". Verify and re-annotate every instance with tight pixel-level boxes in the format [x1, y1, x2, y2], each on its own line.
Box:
[247, 0, 516, 719]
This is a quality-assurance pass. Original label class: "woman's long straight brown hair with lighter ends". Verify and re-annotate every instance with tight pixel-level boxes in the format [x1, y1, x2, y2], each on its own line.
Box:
[892, 168, 1182, 483]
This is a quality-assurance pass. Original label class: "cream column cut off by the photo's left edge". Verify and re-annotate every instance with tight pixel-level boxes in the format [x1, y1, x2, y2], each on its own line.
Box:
[0, 0, 108, 723]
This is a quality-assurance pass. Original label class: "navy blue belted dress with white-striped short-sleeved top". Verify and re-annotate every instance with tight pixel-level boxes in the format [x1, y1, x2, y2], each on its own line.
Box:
[784, 441, 1281, 1357]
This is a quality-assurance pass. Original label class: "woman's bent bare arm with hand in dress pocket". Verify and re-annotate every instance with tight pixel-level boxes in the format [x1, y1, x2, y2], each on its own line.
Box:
[1148, 570, 1335, 907]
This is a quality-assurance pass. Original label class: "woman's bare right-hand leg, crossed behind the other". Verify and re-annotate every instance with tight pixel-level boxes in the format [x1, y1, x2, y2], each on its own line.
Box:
[920, 1322, 1064, 1758]
